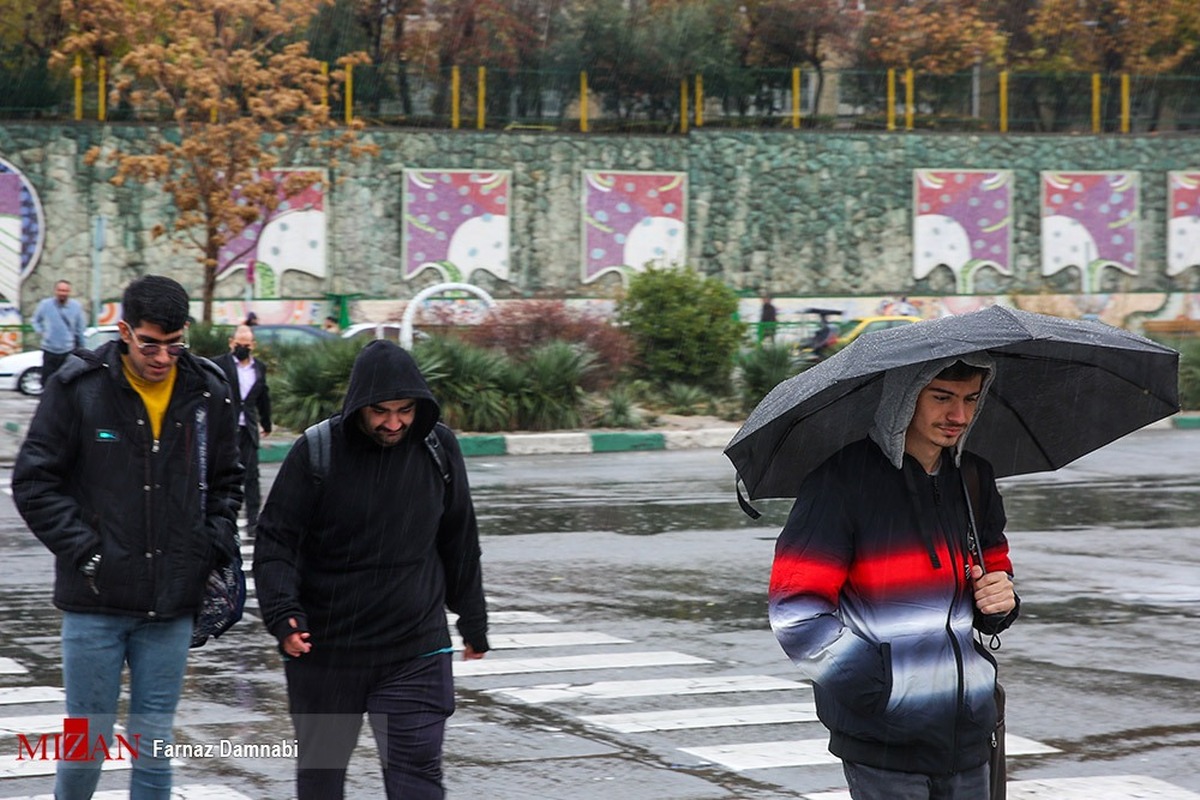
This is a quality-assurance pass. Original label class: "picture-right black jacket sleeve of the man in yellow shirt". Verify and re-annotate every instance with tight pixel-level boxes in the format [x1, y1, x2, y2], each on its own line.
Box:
[204, 381, 245, 566]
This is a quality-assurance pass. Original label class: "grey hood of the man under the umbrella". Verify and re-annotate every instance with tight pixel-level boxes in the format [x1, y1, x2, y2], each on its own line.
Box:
[869, 353, 996, 469]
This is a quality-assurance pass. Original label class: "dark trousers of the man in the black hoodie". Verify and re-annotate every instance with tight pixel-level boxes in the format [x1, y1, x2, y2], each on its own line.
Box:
[284, 644, 454, 800]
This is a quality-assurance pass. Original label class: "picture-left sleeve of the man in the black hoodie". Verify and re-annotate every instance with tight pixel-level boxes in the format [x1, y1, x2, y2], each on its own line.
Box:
[254, 435, 320, 642]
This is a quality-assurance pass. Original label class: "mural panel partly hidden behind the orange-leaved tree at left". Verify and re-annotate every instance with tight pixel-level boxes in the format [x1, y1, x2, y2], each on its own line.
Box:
[217, 168, 329, 297]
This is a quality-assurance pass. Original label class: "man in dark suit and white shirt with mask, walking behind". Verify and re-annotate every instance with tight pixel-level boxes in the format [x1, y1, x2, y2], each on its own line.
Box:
[215, 325, 271, 534]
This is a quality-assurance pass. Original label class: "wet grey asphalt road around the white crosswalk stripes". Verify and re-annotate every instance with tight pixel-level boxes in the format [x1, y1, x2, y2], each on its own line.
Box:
[0, 429, 1200, 800]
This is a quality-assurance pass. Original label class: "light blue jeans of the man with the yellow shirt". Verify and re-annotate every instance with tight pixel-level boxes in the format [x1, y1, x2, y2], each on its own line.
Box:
[54, 612, 192, 800]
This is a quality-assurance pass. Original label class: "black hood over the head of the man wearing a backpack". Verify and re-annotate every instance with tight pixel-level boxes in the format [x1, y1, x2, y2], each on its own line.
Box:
[342, 339, 442, 440]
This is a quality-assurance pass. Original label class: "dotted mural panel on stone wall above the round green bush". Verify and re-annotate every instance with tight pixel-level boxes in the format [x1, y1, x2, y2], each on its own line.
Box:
[582, 170, 688, 283]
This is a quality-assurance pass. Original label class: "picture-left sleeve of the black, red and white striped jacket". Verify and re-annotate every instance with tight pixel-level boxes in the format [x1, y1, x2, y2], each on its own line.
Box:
[768, 473, 888, 712]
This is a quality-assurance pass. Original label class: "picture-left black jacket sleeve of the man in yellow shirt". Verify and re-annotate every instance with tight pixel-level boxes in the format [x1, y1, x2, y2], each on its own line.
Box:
[12, 380, 101, 565]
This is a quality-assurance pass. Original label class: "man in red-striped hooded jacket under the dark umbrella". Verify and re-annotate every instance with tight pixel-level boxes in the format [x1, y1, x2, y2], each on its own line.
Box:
[769, 356, 1019, 800]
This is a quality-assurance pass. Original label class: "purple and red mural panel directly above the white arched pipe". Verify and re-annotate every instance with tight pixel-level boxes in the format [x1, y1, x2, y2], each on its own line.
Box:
[401, 169, 512, 282]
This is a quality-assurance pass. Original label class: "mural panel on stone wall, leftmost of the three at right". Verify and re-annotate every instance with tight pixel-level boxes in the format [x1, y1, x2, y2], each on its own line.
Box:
[912, 169, 1013, 294]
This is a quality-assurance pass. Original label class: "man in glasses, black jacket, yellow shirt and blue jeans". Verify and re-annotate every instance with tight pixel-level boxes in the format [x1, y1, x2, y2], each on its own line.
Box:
[12, 276, 241, 800]
